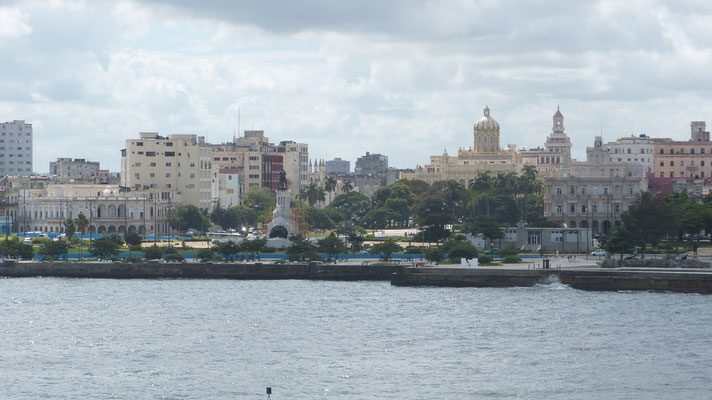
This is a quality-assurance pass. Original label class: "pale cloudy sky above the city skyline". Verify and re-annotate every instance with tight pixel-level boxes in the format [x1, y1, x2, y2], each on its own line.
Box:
[0, 0, 712, 173]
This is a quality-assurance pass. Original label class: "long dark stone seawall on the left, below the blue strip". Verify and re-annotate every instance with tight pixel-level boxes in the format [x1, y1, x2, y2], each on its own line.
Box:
[0, 262, 403, 281]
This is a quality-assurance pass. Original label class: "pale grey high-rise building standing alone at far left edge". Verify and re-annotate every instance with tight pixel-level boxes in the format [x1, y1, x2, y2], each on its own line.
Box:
[0, 120, 32, 176]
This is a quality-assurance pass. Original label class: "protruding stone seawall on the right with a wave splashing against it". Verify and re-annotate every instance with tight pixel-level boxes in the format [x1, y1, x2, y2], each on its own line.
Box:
[391, 268, 712, 294]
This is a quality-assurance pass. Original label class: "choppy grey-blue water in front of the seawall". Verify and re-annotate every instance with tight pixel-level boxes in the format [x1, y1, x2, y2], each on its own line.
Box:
[0, 278, 712, 400]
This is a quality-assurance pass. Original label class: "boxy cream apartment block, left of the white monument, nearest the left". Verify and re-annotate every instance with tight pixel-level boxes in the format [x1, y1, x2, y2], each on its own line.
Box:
[121, 132, 212, 209]
